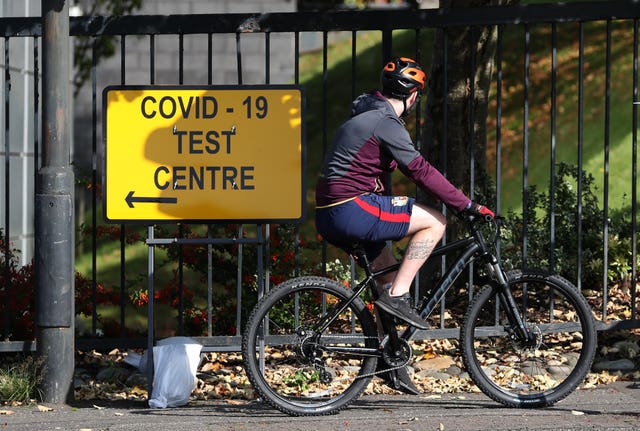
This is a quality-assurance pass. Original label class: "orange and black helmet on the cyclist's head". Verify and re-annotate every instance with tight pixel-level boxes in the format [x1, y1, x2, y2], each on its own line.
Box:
[380, 57, 427, 99]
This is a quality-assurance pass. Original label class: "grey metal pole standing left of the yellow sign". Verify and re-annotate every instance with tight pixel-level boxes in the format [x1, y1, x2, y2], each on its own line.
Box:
[35, 0, 75, 404]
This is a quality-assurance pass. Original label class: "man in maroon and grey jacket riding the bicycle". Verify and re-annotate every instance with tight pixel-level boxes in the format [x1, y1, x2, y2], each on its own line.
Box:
[316, 57, 494, 394]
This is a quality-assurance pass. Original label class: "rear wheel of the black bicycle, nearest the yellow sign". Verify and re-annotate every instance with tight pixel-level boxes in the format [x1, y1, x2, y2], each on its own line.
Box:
[242, 277, 379, 416]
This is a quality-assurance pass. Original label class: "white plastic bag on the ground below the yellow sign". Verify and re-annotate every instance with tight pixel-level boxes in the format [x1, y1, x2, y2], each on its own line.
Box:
[149, 337, 202, 408]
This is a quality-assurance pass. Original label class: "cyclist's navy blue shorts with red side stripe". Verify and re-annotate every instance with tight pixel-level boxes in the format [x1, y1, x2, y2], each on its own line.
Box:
[316, 194, 415, 261]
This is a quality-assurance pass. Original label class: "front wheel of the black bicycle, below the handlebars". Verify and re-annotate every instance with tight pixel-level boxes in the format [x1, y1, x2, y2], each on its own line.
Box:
[460, 271, 596, 407]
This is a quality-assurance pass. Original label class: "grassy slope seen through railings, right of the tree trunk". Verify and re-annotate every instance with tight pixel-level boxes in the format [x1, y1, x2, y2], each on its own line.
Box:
[493, 21, 633, 213]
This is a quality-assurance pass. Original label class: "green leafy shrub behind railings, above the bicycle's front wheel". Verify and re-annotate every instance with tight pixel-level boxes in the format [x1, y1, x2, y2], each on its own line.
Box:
[501, 163, 632, 289]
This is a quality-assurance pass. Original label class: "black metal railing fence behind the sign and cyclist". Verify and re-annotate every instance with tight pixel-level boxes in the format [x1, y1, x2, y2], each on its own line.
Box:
[0, 1, 640, 351]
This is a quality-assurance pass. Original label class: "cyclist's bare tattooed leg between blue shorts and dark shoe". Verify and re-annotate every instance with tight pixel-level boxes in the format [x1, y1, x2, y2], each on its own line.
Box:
[389, 204, 446, 296]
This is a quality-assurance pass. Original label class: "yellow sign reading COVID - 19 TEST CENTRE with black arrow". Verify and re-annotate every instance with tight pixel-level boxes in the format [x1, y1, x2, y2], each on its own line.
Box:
[103, 86, 305, 222]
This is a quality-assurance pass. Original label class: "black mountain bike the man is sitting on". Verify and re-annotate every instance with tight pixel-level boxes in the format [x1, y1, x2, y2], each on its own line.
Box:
[242, 215, 596, 416]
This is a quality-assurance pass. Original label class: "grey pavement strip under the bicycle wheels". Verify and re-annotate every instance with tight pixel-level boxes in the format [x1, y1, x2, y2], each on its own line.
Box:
[0, 382, 640, 431]
